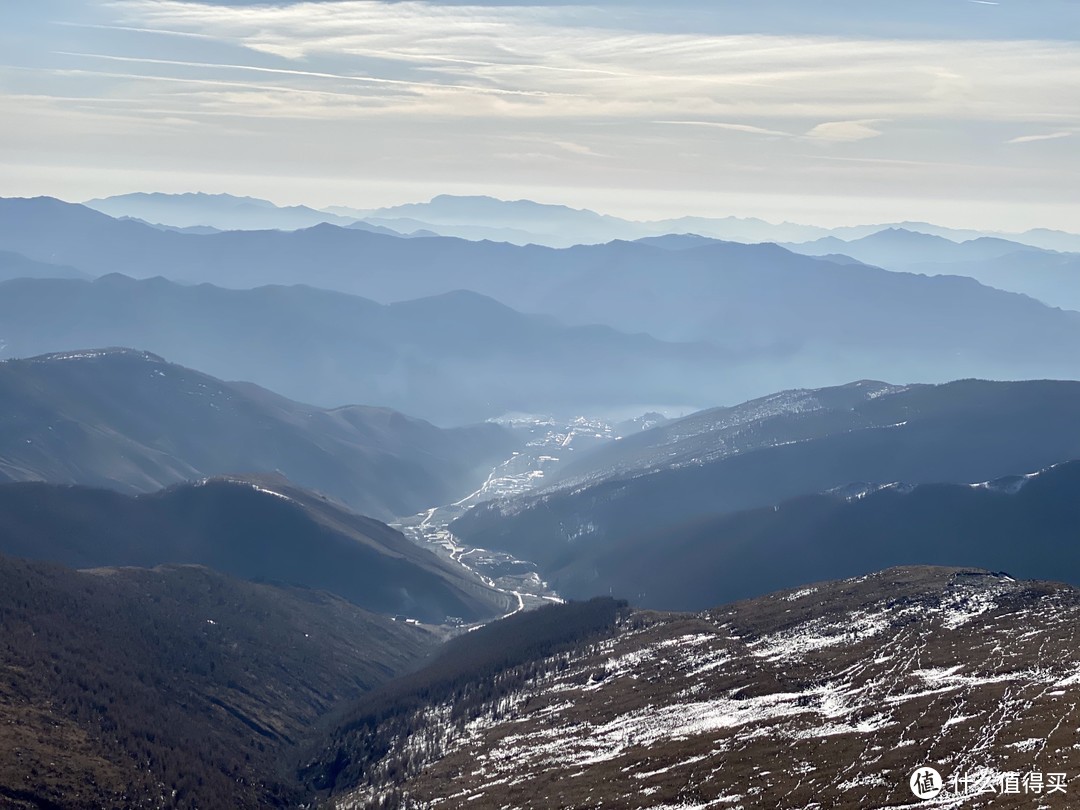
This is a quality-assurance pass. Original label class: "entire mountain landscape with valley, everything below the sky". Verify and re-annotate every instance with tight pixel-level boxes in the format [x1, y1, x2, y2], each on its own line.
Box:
[0, 186, 1080, 810]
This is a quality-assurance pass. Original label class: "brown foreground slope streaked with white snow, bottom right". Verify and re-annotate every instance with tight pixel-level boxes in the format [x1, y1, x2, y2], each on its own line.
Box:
[334, 567, 1080, 810]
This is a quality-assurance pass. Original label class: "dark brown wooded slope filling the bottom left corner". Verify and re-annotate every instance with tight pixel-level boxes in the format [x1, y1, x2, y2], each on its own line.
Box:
[0, 552, 441, 810]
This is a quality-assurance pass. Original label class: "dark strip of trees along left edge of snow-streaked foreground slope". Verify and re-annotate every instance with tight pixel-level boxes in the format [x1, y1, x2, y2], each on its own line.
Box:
[300, 597, 629, 810]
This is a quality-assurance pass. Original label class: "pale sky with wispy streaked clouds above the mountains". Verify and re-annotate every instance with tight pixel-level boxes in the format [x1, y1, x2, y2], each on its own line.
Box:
[0, 0, 1080, 231]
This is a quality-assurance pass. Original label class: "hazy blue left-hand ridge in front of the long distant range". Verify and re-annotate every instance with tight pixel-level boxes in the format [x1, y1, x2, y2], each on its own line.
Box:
[0, 275, 727, 425]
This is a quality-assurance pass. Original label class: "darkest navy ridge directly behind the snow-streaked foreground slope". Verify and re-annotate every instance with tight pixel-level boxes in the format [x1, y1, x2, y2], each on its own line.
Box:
[544, 461, 1080, 610]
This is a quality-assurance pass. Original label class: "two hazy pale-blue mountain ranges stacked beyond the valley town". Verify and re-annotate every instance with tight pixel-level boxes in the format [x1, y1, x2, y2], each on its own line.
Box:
[0, 200, 1080, 423]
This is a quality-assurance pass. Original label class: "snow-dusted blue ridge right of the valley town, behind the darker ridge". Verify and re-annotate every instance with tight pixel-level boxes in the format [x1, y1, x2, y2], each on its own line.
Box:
[451, 380, 1080, 578]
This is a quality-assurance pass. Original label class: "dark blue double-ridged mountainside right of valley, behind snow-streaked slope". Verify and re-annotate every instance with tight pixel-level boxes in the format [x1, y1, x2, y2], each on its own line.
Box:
[450, 380, 1080, 609]
